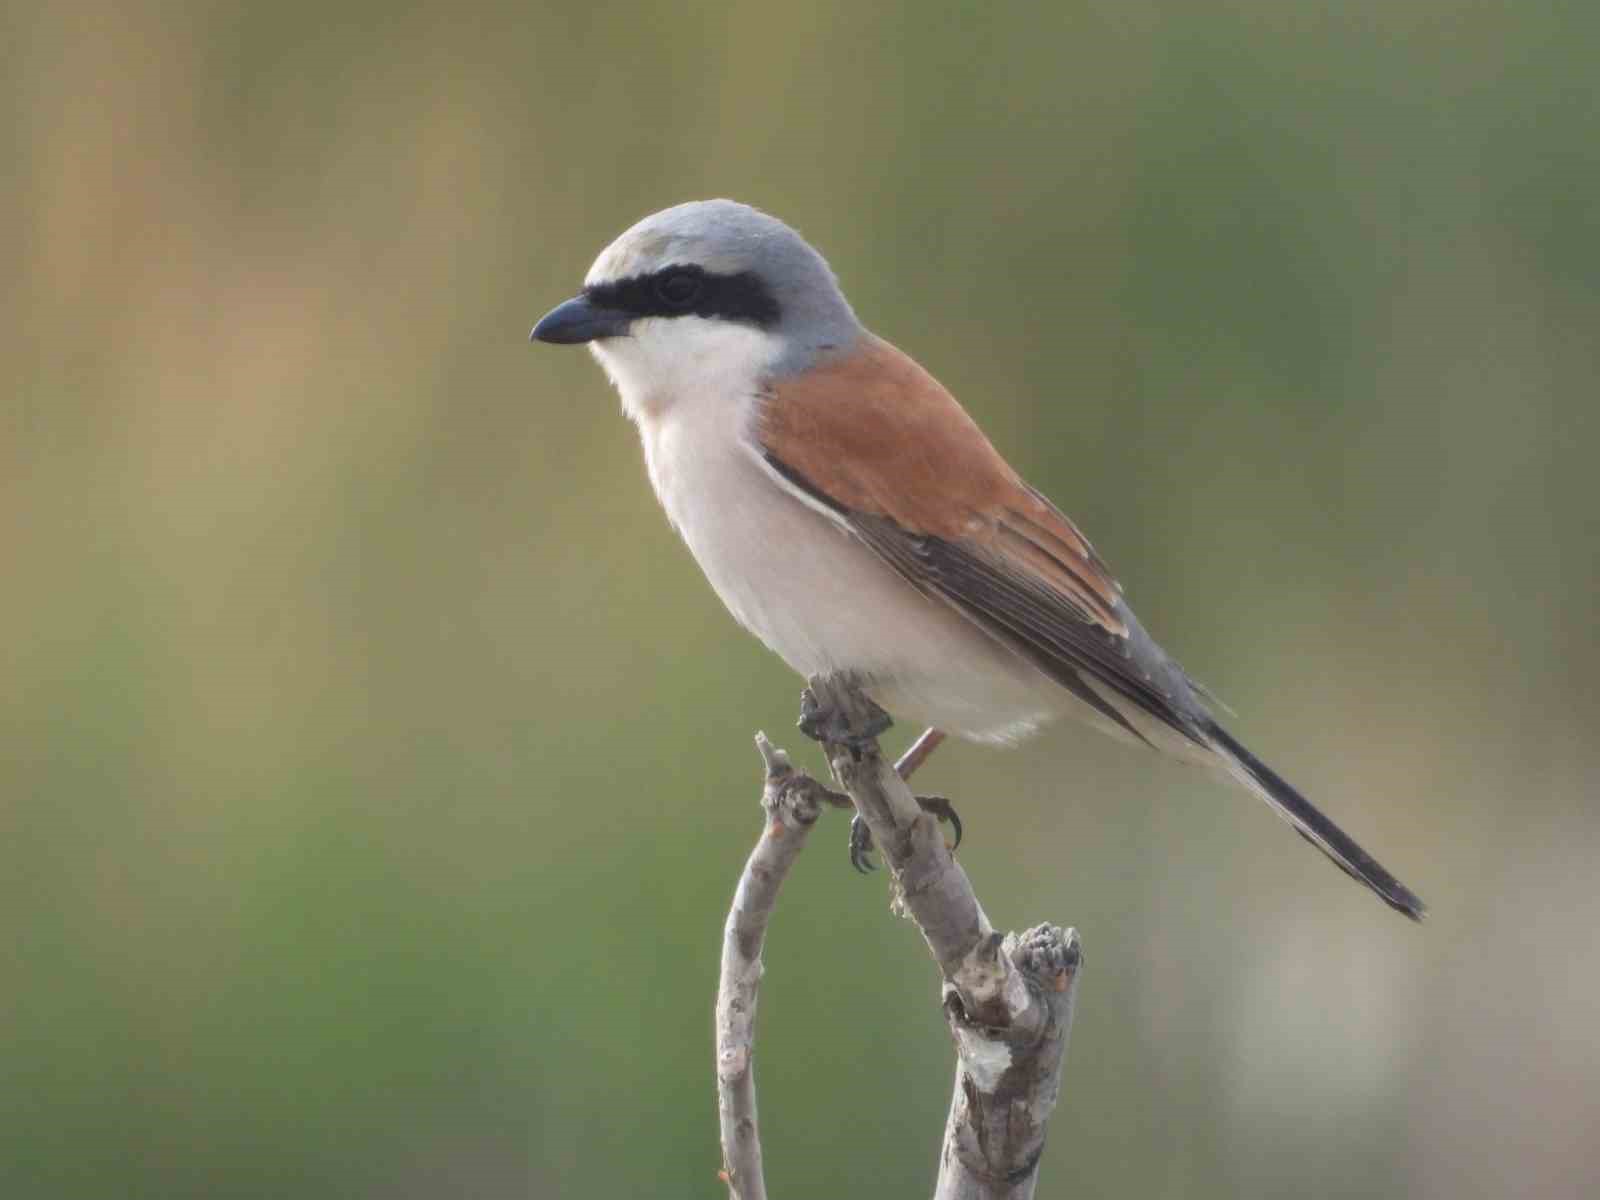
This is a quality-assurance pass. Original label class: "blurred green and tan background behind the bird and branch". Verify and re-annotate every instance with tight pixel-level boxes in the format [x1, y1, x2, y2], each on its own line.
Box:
[0, 0, 1600, 1198]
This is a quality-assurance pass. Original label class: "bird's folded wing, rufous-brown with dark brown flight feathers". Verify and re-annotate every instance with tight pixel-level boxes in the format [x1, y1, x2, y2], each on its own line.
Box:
[757, 336, 1195, 738]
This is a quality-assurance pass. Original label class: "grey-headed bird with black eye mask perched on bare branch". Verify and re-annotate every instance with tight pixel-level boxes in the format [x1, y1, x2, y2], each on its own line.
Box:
[531, 200, 1426, 920]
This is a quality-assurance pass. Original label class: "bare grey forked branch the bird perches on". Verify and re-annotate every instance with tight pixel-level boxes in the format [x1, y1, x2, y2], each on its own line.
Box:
[717, 678, 1082, 1200]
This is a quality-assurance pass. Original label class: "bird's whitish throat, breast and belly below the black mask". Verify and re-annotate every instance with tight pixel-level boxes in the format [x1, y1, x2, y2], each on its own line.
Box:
[595, 318, 1061, 741]
